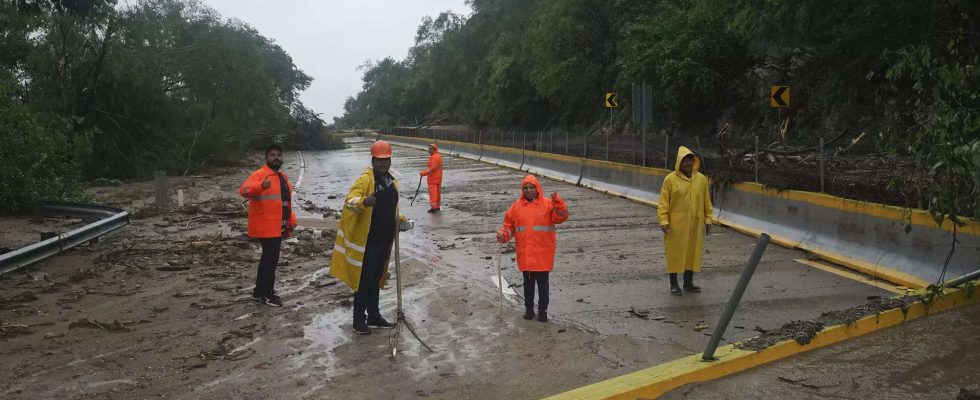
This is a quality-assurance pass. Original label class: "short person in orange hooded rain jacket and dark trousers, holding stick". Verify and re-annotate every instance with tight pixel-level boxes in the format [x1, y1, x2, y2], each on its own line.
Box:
[497, 175, 568, 322]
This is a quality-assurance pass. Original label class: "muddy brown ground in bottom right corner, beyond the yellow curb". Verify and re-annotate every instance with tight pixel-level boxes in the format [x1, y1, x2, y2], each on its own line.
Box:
[663, 305, 980, 400]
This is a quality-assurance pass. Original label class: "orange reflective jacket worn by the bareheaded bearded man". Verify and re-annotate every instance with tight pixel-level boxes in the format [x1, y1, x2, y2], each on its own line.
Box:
[238, 165, 296, 238]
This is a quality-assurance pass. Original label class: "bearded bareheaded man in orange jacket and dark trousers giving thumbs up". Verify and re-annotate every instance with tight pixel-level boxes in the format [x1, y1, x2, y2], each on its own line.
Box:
[238, 144, 296, 307]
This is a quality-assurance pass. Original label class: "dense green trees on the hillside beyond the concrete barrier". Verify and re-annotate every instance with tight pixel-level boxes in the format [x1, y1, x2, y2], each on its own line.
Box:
[338, 0, 980, 218]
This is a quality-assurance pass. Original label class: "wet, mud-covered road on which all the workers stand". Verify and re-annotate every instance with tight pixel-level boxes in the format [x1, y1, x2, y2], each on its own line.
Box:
[0, 142, 904, 399]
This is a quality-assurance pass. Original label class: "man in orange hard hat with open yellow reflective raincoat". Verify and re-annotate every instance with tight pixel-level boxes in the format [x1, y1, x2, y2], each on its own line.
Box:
[330, 140, 404, 334]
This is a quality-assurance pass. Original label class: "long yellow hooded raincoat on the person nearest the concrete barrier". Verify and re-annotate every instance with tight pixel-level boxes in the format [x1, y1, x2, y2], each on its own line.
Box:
[657, 146, 713, 273]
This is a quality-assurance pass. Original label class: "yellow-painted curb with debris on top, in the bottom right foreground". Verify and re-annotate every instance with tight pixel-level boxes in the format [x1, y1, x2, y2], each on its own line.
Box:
[547, 289, 978, 400]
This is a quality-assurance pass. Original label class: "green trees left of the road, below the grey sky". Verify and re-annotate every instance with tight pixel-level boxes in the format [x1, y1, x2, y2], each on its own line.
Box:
[0, 0, 334, 211]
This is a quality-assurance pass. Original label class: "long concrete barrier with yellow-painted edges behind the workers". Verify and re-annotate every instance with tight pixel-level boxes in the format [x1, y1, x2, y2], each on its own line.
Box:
[384, 136, 980, 289]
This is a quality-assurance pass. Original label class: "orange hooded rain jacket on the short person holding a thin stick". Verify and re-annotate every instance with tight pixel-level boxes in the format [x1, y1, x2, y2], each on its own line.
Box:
[500, 175, 568, 271]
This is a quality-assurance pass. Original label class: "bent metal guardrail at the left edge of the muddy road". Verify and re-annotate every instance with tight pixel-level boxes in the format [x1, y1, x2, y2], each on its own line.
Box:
[0, 202, 129, 274]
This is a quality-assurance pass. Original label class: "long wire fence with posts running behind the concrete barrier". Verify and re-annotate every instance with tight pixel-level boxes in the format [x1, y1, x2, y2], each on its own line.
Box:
[380, 127, 928, 208]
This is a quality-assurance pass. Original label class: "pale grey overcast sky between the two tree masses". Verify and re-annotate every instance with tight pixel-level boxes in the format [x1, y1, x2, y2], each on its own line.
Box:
[203, 0, 470, 123]
